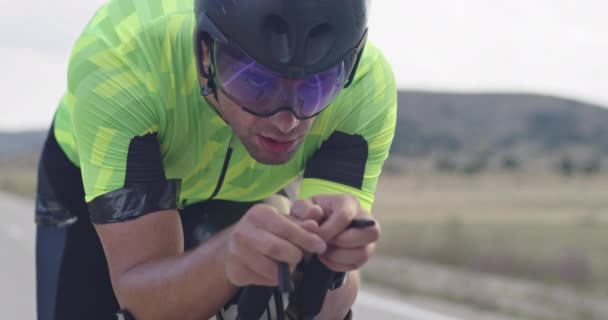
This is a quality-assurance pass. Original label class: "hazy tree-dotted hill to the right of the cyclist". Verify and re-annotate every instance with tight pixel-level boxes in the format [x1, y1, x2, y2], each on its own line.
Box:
[392, 91, 608, 157]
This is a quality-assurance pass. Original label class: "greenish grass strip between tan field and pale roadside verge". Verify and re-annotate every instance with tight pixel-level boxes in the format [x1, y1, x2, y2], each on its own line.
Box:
[379, 218, 608, 290]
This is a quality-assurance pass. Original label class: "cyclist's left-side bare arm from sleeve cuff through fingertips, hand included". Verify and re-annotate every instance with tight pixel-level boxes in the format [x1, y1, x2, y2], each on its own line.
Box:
[96, 205, 326, 320]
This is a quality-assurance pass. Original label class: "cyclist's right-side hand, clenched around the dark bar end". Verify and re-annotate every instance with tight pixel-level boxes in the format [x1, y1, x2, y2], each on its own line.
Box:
[290, 195, 380, 272]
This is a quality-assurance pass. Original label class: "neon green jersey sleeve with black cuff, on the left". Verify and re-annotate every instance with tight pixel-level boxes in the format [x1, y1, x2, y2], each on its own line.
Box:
[68, 34, 179, 223]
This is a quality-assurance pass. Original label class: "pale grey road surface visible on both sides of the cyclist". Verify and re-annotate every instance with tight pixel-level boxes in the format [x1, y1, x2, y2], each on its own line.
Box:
[0, 193, 461, 320]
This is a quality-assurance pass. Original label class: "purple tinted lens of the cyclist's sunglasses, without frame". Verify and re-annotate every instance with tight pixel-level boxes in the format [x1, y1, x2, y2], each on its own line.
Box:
[215, 43, 349, 117]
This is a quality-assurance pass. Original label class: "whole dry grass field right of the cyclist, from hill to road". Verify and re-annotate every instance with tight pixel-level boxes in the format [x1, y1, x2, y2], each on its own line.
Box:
[365, 173, 608, 319]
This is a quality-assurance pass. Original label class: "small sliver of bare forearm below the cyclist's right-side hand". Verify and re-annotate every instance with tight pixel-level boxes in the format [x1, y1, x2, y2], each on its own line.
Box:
[319, 271, 359, 320]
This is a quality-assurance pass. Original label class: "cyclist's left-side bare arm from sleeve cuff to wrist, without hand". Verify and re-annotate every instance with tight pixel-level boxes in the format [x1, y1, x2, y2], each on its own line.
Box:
[95, 210, 236, 319]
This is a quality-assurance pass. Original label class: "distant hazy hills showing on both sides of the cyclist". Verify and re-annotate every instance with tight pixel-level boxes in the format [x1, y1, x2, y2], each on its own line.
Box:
[0, 91, 608, 171]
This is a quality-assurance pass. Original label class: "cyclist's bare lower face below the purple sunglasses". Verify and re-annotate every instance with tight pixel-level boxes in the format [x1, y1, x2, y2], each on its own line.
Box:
[207, 90, 314, 165]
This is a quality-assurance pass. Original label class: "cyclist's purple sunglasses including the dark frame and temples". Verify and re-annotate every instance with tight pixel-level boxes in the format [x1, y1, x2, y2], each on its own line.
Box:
[197, 14, 367, 120]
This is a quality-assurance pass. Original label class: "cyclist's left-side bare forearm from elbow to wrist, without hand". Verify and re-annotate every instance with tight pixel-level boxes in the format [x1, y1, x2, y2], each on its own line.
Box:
[114, 230, 236, 320]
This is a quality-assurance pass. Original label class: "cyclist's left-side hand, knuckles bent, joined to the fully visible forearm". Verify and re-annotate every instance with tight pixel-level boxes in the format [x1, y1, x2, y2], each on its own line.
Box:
[226, 204, 327, 287]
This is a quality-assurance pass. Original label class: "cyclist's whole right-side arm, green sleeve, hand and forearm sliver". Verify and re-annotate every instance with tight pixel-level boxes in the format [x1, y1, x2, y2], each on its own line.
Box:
[291, 42, 397, 320]
